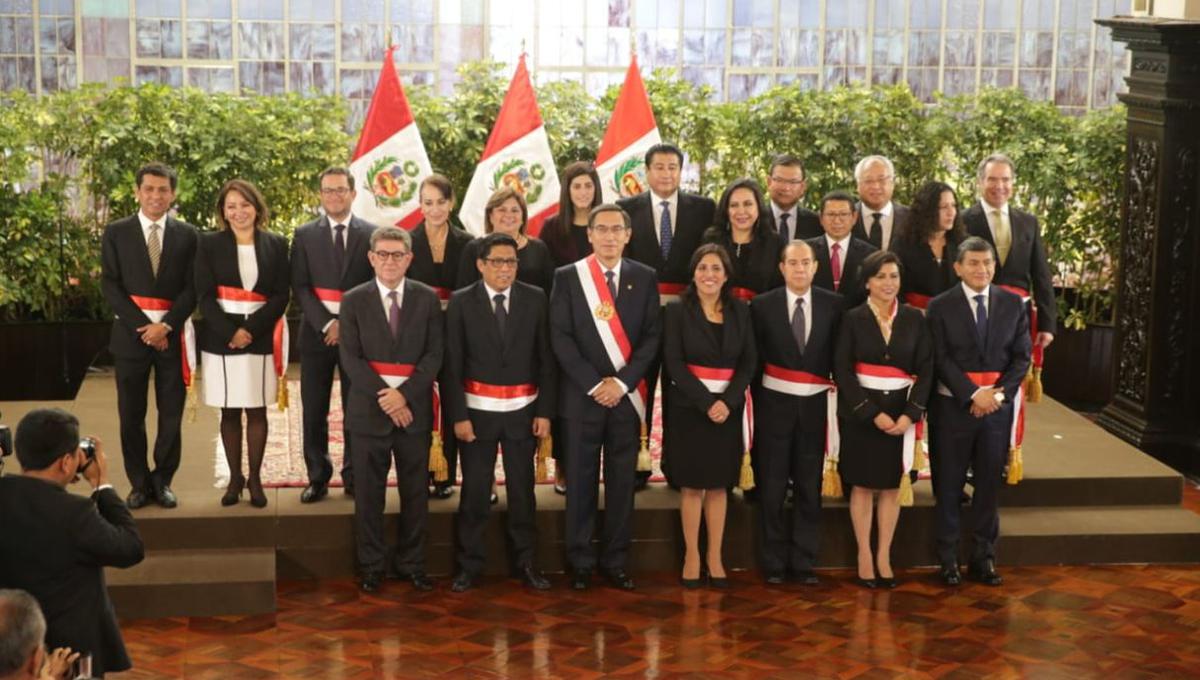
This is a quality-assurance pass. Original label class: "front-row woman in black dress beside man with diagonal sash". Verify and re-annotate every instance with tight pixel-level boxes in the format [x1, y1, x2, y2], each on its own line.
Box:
[662, 243, 758, 588]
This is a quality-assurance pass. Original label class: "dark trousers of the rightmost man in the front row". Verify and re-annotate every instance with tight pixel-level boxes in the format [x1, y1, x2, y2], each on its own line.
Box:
[929, 395, 1013, 565]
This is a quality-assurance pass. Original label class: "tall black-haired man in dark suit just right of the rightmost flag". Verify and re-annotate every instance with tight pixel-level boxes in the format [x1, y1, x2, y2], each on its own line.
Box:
[617, 144, 716, 491]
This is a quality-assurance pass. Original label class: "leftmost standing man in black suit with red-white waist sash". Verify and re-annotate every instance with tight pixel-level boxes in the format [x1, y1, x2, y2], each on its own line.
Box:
[101, 163, 196, 509]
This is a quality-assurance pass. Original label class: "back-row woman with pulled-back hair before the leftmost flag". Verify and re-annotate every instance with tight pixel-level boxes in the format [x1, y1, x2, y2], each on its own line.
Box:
[408, 174, 472, 302]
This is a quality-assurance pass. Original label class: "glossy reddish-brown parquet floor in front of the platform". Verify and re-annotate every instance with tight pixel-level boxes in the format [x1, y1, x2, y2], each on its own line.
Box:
[109, 485, 1200, 680]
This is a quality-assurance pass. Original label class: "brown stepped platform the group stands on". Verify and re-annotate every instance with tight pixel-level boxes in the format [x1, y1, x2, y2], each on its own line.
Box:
[0, 366, 1200, 618]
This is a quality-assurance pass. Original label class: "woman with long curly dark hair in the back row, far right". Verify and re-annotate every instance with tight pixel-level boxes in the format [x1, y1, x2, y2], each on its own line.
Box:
[892, 181, 966, 309]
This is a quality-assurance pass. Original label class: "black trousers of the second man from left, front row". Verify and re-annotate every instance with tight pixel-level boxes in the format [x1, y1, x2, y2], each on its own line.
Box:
[457, 437, 538, 576]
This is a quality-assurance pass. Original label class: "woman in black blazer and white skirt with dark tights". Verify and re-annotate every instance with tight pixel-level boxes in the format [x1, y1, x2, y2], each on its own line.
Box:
[196, 180, 290, 507]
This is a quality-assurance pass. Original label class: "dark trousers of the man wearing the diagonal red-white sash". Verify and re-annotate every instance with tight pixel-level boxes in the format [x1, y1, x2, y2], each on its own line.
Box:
[563, 399, 641, 570]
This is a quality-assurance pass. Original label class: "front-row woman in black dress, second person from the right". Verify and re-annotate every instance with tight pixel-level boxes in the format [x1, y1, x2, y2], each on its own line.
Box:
[833, 251, 934, 588]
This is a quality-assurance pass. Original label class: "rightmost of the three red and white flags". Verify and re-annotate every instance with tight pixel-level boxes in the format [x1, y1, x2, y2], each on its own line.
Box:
[596, 55, 662, 203]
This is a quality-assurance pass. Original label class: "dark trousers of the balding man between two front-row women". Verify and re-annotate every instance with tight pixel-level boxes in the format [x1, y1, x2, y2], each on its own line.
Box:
[755, 425, 824, 573]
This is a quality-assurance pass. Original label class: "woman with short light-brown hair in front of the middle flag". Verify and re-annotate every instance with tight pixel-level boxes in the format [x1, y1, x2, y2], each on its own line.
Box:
[455, 186, 554, 297]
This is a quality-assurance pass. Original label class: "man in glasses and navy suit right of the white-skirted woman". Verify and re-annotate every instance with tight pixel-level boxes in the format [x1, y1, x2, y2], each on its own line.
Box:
[292, 168, 374, 503]
